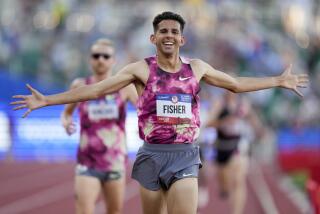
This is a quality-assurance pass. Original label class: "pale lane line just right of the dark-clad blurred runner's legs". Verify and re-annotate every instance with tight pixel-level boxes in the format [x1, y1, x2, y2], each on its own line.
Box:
[248, 160, 279, 214]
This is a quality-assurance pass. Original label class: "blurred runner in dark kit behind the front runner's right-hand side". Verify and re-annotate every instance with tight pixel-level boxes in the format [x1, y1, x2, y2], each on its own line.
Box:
[207, 91, 264, 214]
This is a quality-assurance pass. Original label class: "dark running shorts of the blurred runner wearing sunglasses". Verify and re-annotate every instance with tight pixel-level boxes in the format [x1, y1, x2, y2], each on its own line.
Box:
[76, 164, 124, 182]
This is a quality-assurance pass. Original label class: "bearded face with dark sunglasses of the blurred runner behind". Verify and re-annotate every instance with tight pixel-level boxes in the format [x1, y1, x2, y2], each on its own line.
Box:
[90, 44, 114, 74]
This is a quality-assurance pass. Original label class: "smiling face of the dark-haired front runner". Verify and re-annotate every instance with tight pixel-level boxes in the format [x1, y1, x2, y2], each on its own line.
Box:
[150, 20, 184, 55]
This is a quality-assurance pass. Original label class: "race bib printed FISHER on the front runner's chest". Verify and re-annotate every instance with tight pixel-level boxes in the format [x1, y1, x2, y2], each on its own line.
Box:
[156, 94, 192, 124]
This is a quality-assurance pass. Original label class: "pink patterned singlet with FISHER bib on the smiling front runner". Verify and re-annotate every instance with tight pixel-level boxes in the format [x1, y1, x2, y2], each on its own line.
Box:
[137, 56, 200, 144]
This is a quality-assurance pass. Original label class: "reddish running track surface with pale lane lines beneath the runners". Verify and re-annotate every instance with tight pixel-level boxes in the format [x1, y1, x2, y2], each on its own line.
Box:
[0, 161, 301, 214]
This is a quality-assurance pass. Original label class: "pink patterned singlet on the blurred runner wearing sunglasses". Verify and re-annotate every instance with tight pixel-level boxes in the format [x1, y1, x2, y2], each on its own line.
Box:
[77, 78, 127, 171]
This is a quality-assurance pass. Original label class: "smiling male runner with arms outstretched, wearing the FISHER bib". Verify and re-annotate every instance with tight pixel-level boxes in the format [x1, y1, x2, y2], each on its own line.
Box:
[12, 12, 308, 214]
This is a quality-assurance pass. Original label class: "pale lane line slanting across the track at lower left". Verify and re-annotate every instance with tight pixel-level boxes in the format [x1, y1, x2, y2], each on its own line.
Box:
[0, 182, 73, 213]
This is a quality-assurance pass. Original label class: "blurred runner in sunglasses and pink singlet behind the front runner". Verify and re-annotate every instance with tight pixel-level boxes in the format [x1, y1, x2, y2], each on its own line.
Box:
[61, 39, 137, 214]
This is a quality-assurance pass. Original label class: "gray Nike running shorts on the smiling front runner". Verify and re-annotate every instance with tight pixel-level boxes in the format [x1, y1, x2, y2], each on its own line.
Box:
[131, 143, 201, 191]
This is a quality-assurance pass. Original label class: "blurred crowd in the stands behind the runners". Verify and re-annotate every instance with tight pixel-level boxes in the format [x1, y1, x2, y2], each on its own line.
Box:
[0, 0, 320, 128]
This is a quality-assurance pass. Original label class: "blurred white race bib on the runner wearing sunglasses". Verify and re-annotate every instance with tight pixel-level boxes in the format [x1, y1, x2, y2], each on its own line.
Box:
[88, 102, 119, 120]
